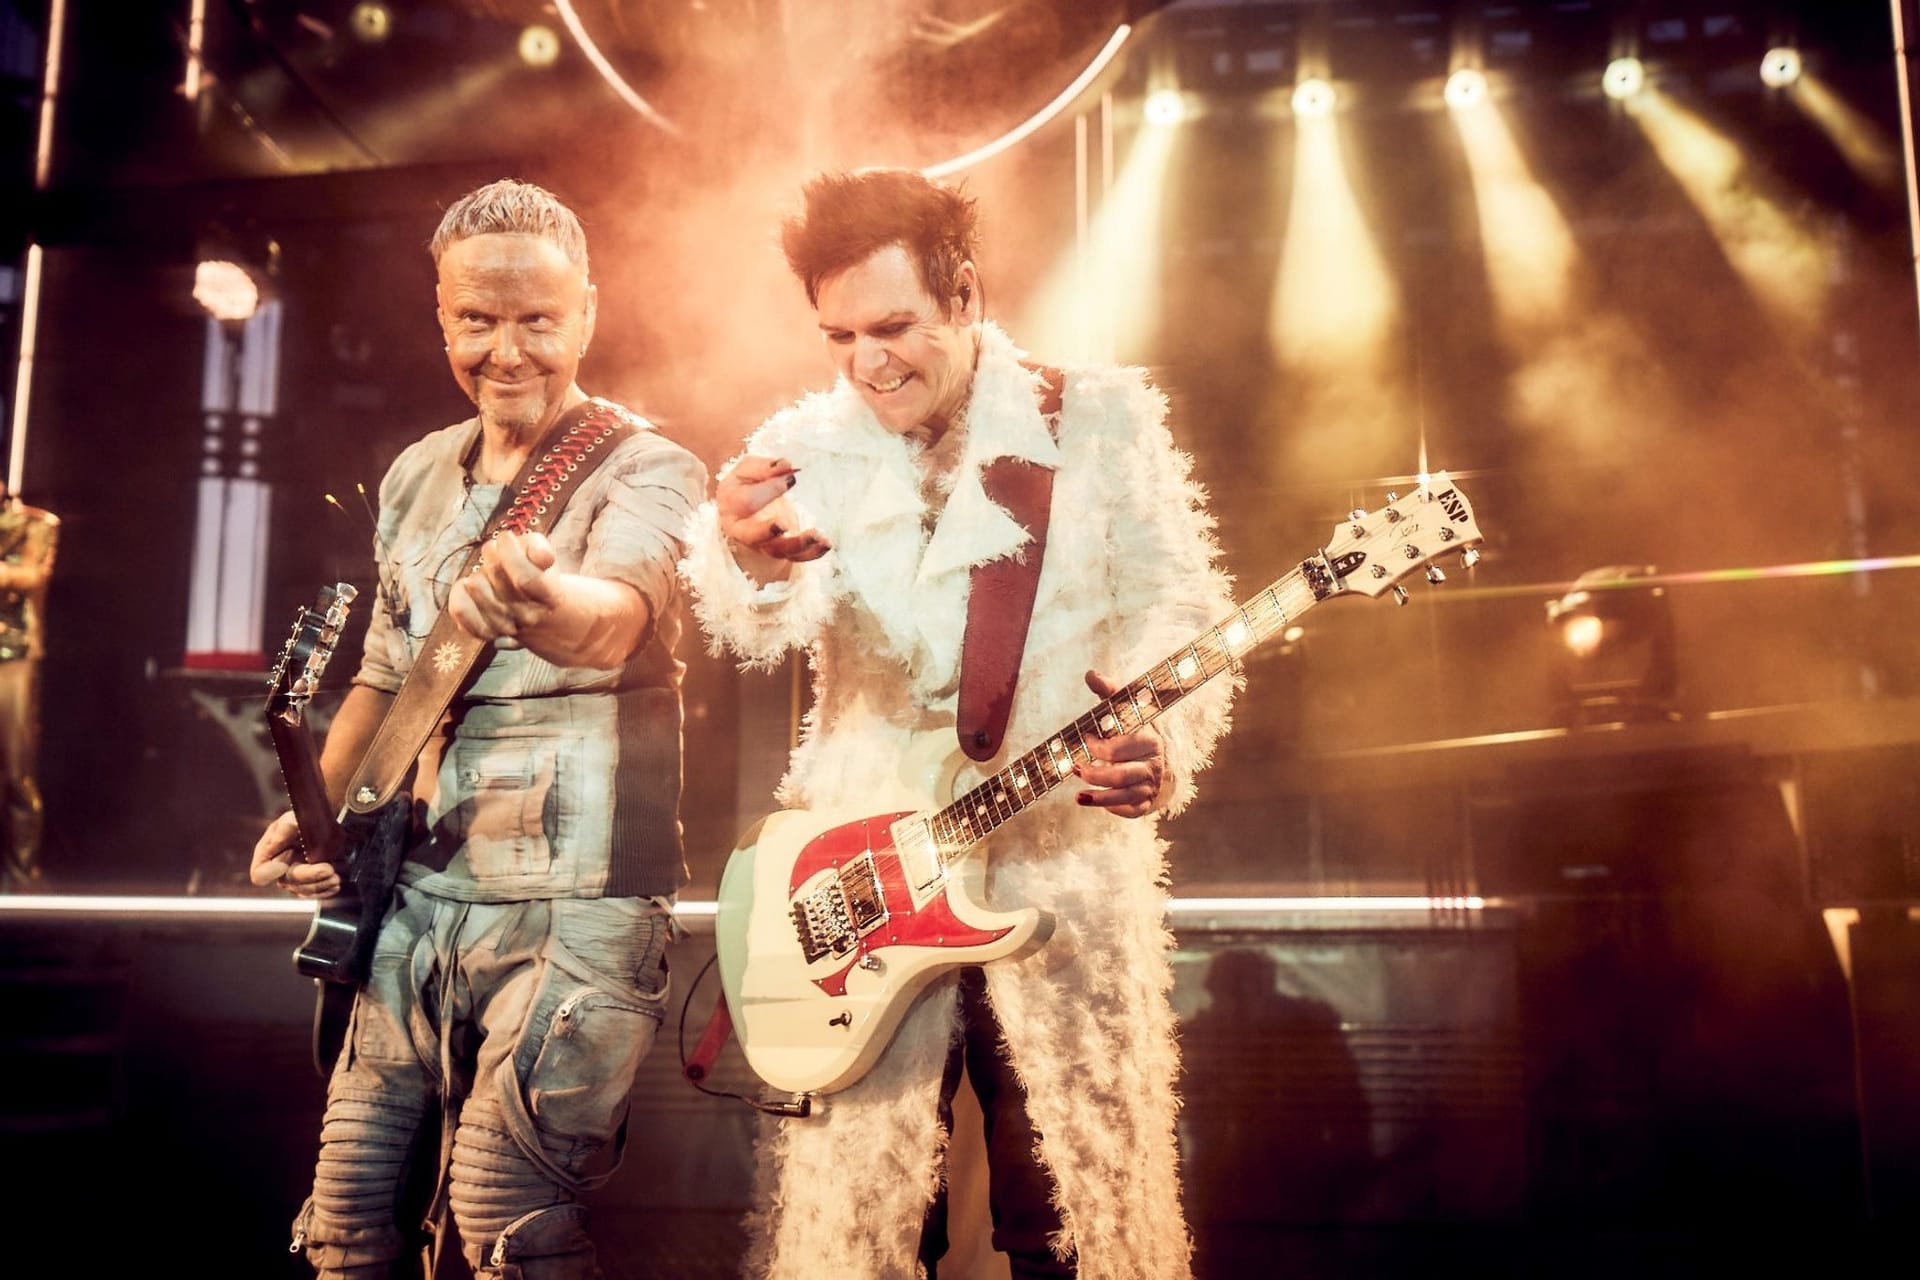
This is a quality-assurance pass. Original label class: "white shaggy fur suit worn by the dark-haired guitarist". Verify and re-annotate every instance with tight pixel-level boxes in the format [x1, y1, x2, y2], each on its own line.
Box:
[682, 324, 1240, 1280]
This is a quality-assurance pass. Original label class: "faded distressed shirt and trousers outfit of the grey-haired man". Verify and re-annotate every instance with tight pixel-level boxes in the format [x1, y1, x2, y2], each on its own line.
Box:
[294, 402, 707, 1280]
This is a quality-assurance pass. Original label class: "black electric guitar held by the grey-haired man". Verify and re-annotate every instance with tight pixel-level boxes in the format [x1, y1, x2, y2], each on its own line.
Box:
[267, 581, 409, 1075]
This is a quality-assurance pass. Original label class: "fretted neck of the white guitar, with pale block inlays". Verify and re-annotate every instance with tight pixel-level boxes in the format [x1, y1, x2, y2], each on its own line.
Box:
[927, 557, 1334, 864]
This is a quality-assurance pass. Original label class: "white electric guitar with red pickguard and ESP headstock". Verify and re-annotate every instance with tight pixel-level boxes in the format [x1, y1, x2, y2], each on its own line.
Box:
[714, 472, 1480, 1094]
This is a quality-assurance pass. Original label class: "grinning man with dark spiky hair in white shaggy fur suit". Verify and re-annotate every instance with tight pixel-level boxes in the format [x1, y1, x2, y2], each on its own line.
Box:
[682, 169, 1235, 1280]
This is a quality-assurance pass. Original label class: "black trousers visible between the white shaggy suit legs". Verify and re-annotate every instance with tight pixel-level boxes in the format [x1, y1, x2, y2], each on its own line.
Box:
[920, 967, 1079, 1280]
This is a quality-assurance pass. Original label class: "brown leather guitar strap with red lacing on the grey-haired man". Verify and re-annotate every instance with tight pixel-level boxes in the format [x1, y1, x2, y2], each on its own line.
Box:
[346, 399, 637, 814]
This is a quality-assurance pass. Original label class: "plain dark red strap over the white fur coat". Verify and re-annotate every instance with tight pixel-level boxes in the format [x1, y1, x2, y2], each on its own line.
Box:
[954, 360, 1064, 760]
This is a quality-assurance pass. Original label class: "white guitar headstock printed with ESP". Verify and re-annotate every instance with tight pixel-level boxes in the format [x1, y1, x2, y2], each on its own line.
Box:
[1321, 472, 1480, 604]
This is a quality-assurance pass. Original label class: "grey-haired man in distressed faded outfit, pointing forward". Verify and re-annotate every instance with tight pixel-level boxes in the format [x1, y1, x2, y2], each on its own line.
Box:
[252, 180, 707, 1280]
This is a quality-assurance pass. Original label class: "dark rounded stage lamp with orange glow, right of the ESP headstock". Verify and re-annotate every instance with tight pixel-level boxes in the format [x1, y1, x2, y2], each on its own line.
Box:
[1548, 564, 1678, 727]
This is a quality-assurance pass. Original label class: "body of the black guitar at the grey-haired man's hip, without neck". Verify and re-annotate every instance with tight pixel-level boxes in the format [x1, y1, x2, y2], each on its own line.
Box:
[294, 793, 413, 1075]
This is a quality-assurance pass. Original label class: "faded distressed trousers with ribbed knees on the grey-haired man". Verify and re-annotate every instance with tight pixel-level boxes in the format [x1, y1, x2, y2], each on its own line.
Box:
[294, 887, 672, 1280]
